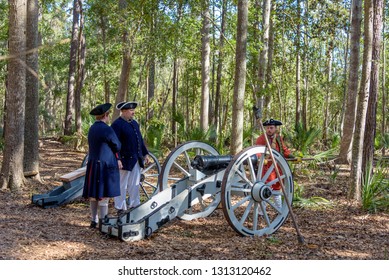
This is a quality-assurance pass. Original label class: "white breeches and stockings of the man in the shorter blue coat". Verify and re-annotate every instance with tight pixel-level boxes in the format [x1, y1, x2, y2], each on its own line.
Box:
[114, 162, 141, 210]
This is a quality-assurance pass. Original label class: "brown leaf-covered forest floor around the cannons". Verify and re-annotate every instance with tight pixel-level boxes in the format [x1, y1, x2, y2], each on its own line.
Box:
[0, 139, 389, 260]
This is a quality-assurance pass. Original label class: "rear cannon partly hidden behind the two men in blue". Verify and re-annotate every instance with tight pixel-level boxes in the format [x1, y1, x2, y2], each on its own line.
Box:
[31, 153, 161, 208]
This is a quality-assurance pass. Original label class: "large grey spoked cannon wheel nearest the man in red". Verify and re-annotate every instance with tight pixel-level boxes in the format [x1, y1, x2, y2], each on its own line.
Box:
[222, 146, 294, 236]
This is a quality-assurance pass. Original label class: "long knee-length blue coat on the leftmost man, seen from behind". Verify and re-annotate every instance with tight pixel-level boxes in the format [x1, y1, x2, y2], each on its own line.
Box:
[82, 121, 121, 199]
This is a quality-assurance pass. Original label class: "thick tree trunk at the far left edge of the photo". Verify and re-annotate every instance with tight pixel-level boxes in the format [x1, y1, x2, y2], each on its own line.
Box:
[0, 0, 27, 192]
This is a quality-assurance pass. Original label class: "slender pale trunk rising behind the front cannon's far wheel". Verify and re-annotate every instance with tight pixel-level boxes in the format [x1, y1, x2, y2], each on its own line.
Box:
[200, 0, 211, 131]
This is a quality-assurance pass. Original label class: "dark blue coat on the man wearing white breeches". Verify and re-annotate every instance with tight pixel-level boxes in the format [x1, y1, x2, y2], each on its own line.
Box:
[111, 117, 149, 171]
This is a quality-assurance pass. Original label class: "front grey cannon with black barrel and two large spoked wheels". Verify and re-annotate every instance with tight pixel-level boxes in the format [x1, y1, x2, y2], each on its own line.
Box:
[99, 141, 294, 241]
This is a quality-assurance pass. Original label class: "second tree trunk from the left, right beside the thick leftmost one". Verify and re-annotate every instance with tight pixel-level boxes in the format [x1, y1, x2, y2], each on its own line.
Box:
[24, 0, 40, 181]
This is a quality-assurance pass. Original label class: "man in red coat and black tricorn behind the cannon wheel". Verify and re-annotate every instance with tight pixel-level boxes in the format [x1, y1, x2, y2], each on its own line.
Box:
[255, 119, 294, 208]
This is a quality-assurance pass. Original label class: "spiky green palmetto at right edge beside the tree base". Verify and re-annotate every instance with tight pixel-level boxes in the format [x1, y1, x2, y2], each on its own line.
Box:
[362, 162, 389, 213]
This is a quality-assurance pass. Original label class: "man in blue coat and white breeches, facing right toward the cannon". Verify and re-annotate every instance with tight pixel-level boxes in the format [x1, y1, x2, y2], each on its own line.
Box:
[111, 102, 149, 214]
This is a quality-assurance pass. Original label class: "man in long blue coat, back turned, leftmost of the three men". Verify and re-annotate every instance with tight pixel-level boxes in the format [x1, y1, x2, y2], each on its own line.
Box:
[82, 103, 121, 228]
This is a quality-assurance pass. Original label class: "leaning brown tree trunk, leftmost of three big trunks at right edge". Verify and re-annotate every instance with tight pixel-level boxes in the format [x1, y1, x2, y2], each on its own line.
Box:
[338, 0, 362, 163]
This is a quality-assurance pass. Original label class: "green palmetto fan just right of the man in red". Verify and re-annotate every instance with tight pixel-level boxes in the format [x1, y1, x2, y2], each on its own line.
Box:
[285, 123, 321, 155]
